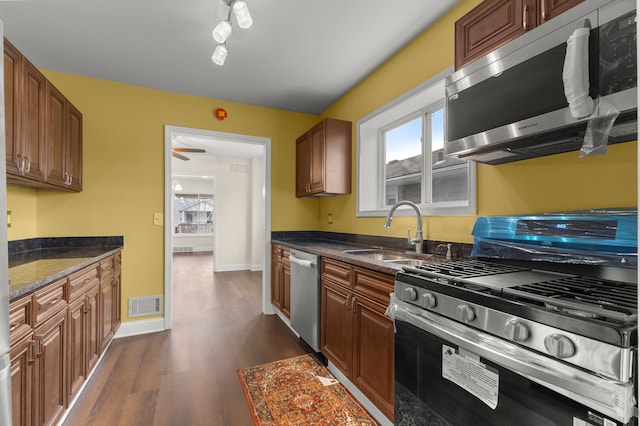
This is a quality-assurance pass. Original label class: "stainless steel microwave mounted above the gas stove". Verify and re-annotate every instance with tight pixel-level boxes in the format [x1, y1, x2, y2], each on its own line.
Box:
[445, 0, 638, 164]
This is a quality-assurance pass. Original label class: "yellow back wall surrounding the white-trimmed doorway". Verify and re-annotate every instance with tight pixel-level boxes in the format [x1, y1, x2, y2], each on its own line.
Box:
[7, 71, 319, 320]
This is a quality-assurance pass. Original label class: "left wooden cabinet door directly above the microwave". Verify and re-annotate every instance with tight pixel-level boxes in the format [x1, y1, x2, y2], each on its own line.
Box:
[454, 0, 538, 70]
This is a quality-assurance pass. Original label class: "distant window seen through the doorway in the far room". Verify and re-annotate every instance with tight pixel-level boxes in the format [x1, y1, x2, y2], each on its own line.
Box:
[173, 194, 213, 235]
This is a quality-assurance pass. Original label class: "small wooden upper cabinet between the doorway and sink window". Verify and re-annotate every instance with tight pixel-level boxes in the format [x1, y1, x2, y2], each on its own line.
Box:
[296, 118, 351, 197]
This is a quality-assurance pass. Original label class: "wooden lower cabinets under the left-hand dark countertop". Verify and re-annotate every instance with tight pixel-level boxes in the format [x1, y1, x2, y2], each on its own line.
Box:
[9, 252, 121, 426]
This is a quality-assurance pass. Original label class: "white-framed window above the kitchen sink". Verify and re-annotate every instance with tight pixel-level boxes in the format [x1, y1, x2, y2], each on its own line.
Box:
[357, 71, 476, 220]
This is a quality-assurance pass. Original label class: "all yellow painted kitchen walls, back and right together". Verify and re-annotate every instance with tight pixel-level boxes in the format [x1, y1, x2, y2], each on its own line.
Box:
[7, 0, 637, 320]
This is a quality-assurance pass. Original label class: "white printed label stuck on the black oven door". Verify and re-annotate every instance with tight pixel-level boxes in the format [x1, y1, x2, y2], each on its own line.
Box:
[442, 345, 499, 410]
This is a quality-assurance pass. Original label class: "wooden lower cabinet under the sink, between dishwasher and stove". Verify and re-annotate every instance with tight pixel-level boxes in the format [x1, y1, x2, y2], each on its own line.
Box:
[321, 258, 395, 420]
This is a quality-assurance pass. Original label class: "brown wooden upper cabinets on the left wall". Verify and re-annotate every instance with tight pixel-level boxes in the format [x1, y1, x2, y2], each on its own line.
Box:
[4, 39, 82, 191]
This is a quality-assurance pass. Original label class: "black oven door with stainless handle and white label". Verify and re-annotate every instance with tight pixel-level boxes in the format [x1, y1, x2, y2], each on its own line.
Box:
[389, 300, 637, 426]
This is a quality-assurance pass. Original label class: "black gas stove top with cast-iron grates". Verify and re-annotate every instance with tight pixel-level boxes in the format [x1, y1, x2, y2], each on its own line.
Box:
[396, 259, 637, 347]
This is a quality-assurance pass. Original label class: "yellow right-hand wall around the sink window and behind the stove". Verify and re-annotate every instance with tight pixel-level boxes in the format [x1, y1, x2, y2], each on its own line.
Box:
[319, 0, 638, 242]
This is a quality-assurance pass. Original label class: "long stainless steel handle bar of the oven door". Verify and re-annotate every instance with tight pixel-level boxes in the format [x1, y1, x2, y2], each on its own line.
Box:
[387, 297, 635, 423]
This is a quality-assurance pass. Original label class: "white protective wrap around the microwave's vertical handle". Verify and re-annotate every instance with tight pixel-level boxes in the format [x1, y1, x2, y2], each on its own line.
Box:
[562, 27, 594, 119]
